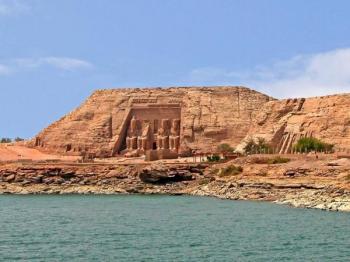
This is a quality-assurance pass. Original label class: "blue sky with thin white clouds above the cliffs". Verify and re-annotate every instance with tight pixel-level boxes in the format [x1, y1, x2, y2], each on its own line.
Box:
[0, 0, 350, 138]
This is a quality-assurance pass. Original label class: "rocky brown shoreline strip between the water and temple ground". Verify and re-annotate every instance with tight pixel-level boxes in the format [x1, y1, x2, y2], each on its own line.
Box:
[0, 158, 350, 211]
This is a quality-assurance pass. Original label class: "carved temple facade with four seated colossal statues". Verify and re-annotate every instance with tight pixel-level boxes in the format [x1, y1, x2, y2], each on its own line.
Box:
[118, 98, 181, 160]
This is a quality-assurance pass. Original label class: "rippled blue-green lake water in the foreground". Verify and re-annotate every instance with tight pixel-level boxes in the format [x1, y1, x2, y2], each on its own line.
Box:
[0, 195, 350, 261]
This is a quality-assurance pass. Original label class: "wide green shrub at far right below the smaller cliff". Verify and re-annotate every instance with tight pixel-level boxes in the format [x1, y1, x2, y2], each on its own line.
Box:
[293, 137, 334, 153]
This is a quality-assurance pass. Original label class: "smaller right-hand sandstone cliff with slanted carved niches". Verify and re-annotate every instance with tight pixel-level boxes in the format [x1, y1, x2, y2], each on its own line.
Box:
[239, 94, 350, 153]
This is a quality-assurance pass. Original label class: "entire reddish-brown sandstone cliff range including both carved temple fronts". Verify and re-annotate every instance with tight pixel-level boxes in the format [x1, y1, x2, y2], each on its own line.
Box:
[30, 86, 350, 160]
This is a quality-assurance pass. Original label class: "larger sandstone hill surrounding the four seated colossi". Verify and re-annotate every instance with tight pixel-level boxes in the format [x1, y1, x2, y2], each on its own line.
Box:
[30, 87, 273, 157]
